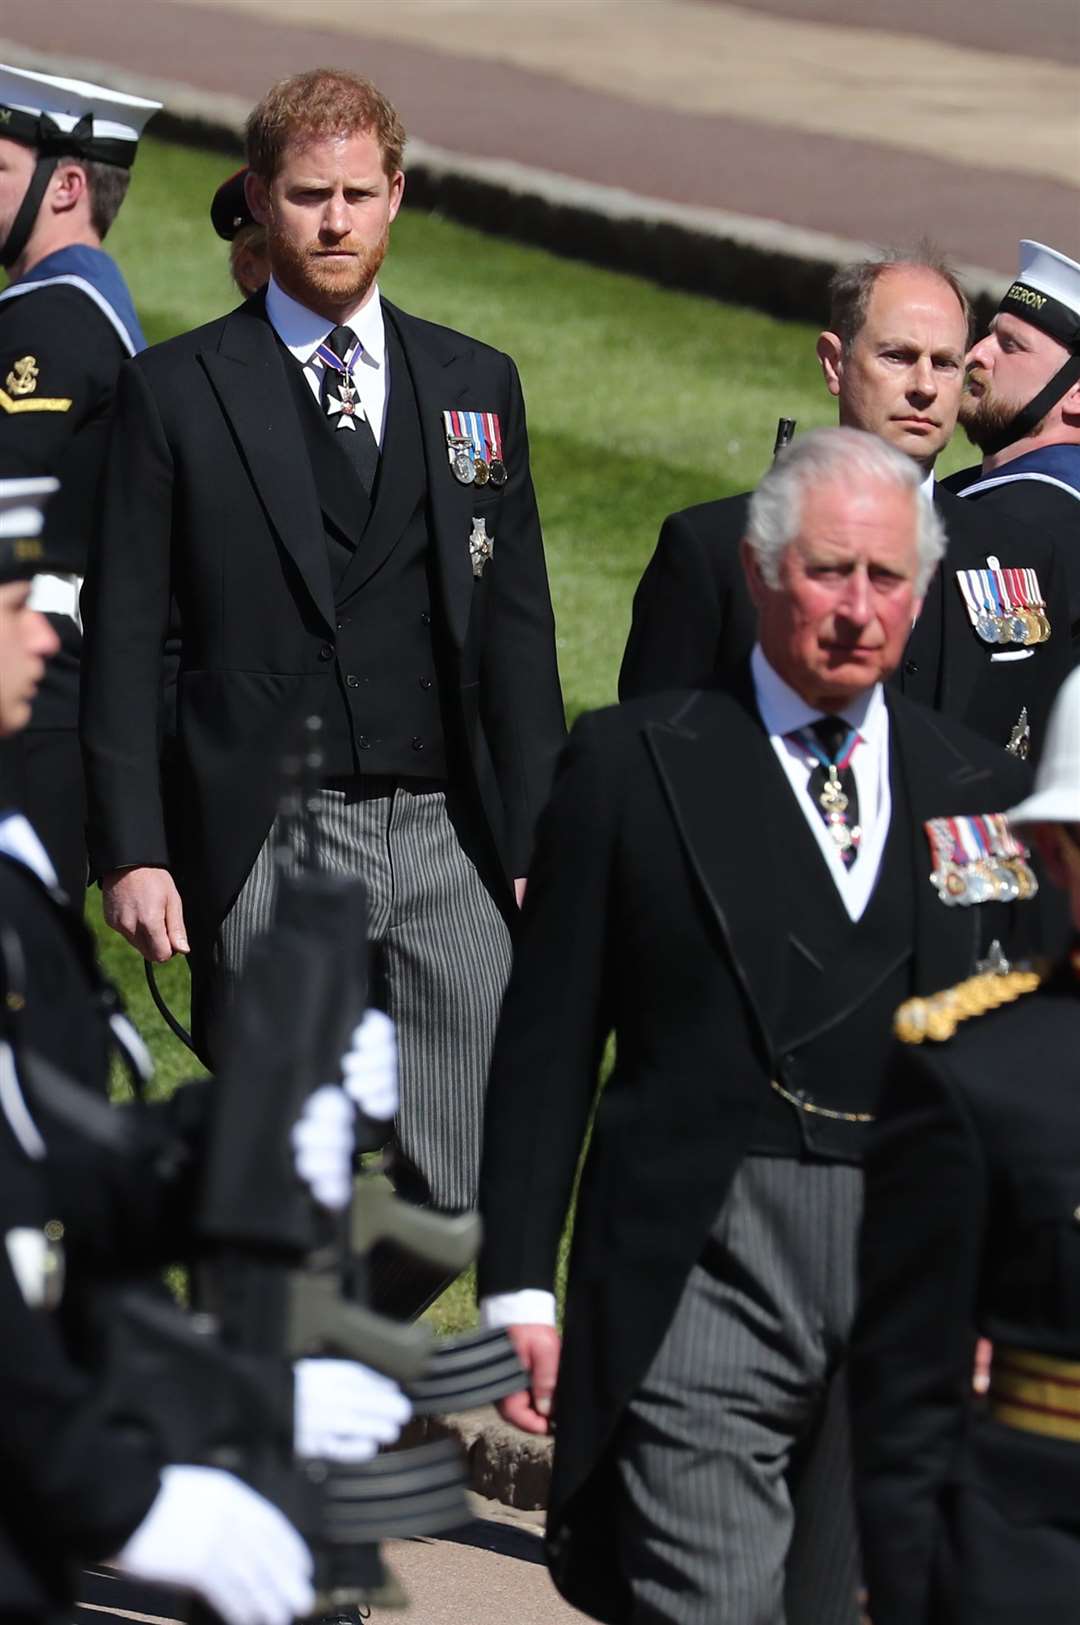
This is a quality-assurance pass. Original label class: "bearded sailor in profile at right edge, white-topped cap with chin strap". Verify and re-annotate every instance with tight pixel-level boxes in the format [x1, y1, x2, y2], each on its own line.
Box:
[945, 241, 1080, 653]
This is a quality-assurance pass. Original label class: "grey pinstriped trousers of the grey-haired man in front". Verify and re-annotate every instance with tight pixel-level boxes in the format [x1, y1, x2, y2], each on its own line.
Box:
[617, 1157, 862, 1625]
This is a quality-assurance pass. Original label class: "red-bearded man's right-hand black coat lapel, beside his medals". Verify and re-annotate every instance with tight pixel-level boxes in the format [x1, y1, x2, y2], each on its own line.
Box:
[383, 301, 484, 648]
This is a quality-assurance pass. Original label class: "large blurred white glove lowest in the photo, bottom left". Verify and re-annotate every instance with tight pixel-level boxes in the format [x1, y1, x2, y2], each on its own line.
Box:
[112, 1467, 315, 1625]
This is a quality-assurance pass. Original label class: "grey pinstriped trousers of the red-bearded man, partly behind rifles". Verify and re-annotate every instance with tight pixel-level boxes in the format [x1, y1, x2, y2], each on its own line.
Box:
[218, 780, 510, 1311]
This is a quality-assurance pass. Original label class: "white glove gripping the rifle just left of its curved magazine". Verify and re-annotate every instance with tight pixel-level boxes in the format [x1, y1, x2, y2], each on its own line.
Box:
[292, 1360, 413, 1461]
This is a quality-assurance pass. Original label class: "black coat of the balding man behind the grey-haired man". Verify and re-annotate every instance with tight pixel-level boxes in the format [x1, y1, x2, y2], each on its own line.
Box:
[619, 486, 1074, 759]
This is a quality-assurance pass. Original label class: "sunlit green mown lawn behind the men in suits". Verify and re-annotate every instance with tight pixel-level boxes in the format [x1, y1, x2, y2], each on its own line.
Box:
[89, 140, 965, 1326]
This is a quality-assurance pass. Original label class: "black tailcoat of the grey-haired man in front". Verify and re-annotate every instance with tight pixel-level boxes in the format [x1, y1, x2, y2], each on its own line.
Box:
[479, 668, 1030, 1620]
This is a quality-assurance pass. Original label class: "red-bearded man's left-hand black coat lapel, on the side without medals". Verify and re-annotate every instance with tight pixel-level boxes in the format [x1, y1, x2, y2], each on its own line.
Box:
[200, 296, 335, 629]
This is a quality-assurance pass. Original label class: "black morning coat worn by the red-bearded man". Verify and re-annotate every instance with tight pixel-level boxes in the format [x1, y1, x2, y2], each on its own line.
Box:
[83, 296, 565, 947]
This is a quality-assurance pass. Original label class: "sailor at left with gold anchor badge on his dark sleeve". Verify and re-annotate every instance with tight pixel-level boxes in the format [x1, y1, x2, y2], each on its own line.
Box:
[0, 65, 161, 908]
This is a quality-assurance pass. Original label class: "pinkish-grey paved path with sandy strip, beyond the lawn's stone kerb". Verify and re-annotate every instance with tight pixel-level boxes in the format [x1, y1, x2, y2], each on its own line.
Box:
[0, 0, 1080, 273]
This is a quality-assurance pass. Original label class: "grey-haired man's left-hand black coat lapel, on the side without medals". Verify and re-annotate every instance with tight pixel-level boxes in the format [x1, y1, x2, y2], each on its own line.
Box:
[645, 668, 788, 1051]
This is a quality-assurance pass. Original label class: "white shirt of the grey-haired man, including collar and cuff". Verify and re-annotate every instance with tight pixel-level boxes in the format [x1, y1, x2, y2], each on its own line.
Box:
[481, 644, 892, 1326]
